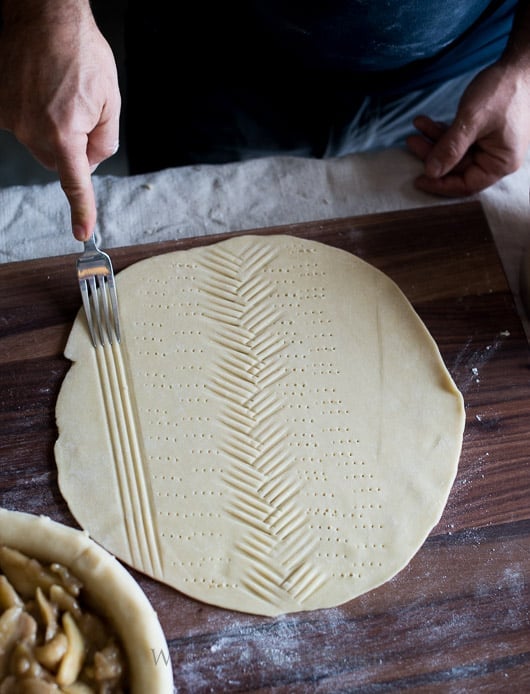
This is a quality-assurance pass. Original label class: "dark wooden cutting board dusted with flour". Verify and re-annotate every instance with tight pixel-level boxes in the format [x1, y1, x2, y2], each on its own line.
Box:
[0, 202, 530, 694]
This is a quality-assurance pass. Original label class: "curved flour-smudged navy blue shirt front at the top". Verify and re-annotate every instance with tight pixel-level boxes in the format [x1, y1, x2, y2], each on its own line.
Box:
[254, 0, 517, 92]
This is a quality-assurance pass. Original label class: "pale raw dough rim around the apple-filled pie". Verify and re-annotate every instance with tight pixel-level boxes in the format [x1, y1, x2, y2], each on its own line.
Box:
[0, 508, 173, 694]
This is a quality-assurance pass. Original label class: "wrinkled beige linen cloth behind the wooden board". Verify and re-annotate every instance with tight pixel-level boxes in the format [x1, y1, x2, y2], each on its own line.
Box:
[0, 149, 530, 336]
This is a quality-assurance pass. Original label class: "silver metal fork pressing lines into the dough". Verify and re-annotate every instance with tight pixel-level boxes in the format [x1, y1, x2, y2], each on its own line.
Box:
[77, 235, 120, 347]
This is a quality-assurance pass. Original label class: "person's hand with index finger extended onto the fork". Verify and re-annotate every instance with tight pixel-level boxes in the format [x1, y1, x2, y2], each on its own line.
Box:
[0, 0, 121, 241]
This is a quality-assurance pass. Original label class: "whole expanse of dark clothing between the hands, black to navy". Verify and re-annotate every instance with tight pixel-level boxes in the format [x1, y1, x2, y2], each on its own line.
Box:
[125, 0, 518, 173]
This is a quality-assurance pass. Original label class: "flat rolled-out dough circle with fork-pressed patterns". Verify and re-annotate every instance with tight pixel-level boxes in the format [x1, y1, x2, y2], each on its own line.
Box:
[55, 235, 464, 615]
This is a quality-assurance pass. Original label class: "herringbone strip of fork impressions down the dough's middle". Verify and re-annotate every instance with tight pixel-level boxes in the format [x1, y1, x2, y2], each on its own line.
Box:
[202, 240, 327, 605]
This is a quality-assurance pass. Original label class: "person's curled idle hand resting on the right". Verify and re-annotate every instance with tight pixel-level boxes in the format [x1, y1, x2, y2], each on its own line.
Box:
[407, 62, 530, 197]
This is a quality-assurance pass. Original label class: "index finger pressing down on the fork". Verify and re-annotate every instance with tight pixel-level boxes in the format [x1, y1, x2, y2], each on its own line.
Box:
[56, 139, 97, 241]
